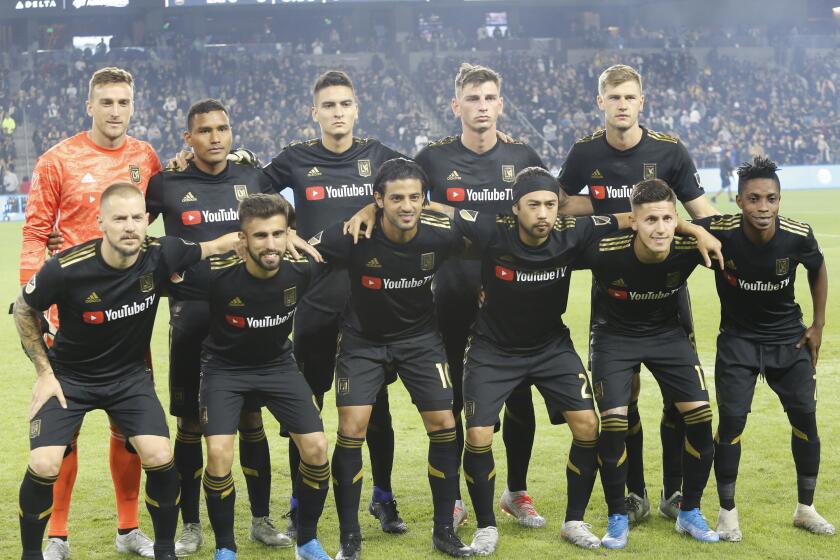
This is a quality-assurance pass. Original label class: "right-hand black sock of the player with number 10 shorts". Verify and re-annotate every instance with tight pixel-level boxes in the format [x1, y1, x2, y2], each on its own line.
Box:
[427, 428, 460, 527]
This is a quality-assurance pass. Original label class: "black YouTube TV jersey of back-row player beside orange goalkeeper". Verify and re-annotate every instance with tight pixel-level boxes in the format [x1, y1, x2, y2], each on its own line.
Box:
[146, 163, 274, 299]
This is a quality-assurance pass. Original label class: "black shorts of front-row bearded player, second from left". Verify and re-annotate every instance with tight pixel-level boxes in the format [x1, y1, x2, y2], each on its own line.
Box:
[199, 355, 324, 436]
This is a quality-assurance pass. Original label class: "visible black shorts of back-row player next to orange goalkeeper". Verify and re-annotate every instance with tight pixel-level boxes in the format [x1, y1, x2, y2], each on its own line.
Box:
[169, 300, 210, 418]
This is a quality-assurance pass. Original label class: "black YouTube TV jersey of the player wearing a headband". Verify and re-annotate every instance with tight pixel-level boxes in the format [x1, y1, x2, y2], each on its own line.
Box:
[456, 210, 616, 353]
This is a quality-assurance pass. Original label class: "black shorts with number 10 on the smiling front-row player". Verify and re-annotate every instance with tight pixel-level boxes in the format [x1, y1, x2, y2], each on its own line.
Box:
[335, 331, 452, 412]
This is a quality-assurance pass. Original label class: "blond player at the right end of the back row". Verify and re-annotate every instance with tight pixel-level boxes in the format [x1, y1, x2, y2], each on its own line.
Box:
[559, 64, 718, 522]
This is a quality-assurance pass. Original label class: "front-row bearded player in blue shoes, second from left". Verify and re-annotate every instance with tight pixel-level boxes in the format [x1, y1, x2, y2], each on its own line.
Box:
[185, 194, 330, 560]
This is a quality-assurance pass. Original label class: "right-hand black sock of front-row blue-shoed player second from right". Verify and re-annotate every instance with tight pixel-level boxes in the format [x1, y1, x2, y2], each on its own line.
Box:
[680, 404, 715, 511]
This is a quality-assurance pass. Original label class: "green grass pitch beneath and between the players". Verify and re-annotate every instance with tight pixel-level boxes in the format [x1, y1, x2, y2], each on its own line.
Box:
[0, 190, 840, 560]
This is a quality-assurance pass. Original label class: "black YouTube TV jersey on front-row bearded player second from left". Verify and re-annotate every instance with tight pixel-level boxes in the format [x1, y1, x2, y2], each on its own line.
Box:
[195, 253, 312, 370]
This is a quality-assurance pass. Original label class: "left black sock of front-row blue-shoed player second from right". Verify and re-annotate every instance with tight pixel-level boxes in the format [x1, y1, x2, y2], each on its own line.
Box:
[597, 414, 627, 515]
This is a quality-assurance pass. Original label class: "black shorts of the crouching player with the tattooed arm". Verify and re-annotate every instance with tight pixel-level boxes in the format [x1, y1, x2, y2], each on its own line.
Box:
[29, 370, 169, 449]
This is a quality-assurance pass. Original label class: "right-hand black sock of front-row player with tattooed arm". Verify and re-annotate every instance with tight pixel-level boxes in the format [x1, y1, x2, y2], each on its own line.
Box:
[143, 460, 181, 557]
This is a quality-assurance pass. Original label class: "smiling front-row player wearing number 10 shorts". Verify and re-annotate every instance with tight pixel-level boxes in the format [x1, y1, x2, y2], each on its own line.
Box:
[310, 158, 472, 560]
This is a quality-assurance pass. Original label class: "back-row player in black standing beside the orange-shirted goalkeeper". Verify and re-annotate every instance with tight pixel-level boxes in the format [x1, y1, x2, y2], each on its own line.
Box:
[146, 99, 291, 555]
